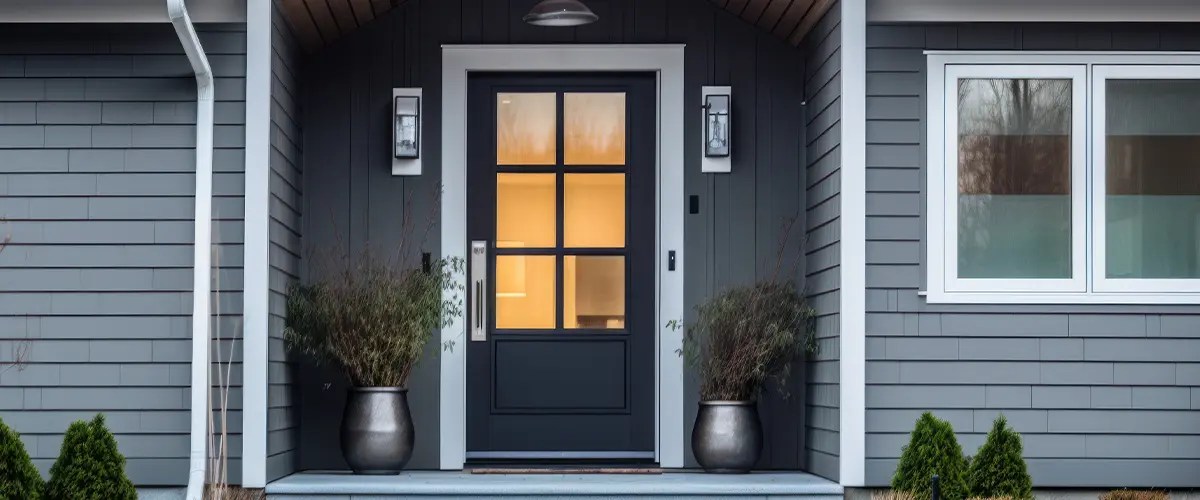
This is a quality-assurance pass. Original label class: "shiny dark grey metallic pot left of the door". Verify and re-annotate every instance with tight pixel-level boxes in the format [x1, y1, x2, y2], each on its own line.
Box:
[342, 387, 414, 475]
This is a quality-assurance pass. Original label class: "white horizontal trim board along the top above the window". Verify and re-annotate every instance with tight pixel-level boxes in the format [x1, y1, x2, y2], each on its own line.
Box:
[868, 0, 1200, 23]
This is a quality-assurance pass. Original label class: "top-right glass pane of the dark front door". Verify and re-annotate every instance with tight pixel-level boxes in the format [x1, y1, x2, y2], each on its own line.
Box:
[563, 92, 625, 165]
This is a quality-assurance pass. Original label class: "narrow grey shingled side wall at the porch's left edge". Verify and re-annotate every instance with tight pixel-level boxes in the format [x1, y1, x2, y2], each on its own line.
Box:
[266, 0, 304, 481]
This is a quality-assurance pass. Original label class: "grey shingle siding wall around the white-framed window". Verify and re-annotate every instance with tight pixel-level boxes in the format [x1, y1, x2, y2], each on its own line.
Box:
[866, 23, 1200, 487]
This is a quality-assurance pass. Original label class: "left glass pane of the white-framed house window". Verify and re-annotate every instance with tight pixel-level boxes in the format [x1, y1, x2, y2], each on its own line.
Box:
[958, 78, 1073, 278]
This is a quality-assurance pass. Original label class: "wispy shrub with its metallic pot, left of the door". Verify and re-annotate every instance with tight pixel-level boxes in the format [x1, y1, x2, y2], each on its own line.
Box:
[284, 200, 466, 475]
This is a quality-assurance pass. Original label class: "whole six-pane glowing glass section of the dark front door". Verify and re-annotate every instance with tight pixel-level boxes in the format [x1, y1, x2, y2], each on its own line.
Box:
[494, 92, 628, 330]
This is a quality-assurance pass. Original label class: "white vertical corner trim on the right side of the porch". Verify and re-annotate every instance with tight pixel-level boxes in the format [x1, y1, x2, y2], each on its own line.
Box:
[838, 0, 868, 487]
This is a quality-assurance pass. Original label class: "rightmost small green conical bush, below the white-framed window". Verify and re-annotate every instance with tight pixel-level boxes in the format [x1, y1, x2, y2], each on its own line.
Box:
[967, 415, 1033, 499]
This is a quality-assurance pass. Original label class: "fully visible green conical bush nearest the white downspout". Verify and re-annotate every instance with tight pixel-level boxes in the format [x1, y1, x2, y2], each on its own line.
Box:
[46, 414, 138, 500]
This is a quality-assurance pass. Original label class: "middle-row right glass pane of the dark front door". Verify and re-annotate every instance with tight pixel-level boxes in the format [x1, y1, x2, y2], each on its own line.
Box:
[563, 174, 624, 248]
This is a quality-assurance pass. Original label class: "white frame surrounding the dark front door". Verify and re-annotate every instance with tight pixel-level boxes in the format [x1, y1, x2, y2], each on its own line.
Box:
[439, 44, 698, 470]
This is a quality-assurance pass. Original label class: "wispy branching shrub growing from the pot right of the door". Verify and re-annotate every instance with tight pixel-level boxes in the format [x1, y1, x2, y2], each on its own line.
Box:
[667, 216, 816, 400]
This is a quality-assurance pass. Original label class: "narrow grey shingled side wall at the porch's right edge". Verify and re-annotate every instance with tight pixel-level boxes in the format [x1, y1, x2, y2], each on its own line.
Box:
[800, 5, 841, 481]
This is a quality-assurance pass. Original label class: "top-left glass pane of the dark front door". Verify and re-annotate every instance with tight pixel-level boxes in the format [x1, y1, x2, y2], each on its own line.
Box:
[496, 92, 558, 165]
